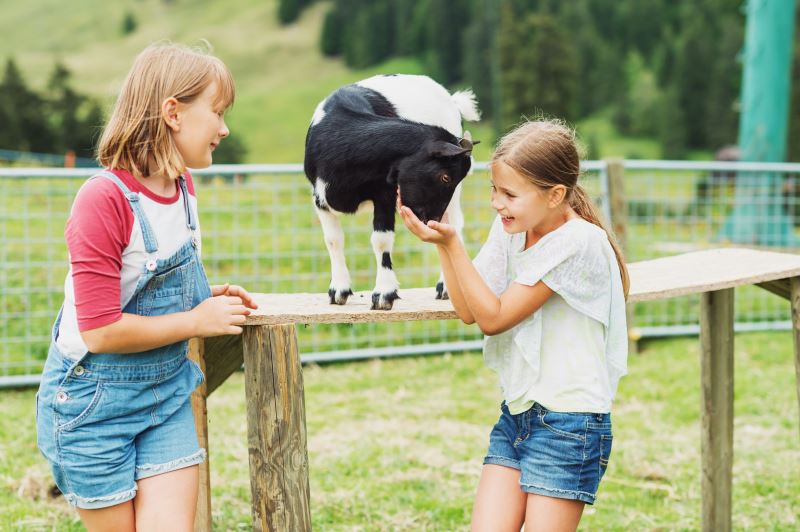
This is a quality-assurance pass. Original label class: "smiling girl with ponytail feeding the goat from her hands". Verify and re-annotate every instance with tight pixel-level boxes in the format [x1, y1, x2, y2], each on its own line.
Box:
[398, 120, 629, 531]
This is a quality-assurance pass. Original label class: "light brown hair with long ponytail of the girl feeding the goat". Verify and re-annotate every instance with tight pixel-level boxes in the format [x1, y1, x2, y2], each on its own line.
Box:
[492, 120, 630, 299]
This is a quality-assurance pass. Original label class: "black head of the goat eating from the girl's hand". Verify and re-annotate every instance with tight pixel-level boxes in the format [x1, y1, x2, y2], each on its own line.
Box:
[389, 131, 480, 223]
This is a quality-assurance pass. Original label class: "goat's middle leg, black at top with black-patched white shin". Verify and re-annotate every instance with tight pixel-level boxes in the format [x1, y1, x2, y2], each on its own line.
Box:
[370, 190, 400, 310]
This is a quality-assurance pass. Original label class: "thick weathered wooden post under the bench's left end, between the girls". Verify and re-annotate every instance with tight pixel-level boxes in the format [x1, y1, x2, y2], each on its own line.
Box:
[243, 325, 311, 532]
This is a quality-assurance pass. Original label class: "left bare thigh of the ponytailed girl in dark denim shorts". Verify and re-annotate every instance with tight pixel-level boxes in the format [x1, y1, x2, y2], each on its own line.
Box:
[471, 464, 527, 532]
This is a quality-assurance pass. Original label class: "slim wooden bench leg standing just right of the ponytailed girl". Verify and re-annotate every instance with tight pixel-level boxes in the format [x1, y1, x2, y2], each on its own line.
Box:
[700, 288, 733, 532]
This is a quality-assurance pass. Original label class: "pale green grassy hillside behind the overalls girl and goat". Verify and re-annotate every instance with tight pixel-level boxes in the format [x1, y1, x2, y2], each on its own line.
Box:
[0, 0, 500, 162]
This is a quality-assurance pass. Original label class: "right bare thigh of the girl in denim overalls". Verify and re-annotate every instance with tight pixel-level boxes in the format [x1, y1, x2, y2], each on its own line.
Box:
[133, 465, 200, 532]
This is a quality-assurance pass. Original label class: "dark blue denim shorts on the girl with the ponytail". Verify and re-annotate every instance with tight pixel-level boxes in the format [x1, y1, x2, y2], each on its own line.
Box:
[483, 402, 612, 504]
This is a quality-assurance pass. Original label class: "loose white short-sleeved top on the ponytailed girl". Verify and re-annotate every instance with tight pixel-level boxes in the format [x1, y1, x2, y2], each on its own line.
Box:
[474, 217, 628, 413]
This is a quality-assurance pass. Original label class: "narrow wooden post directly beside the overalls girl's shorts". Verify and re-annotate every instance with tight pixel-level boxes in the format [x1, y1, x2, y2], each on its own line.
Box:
[188, 338, 211, 532]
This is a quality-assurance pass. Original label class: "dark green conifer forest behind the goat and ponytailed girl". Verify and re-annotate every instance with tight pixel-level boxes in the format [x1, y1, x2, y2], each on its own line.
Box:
[279, 0, 800, 159]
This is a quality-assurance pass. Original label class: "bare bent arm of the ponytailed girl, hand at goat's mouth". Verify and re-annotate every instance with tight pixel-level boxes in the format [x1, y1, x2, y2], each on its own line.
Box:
[400, 205, 553, 335]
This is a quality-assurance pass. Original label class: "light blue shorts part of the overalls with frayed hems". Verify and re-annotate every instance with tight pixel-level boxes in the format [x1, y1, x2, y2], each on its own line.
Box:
[36, 345, 205, 509]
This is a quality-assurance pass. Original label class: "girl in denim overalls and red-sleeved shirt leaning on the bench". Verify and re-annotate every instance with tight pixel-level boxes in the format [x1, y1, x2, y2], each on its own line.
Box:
[36, 43, 256, 531]
